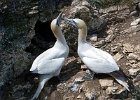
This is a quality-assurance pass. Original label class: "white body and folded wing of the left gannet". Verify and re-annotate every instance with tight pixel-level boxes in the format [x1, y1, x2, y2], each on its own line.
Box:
[30, 47, 68, 74]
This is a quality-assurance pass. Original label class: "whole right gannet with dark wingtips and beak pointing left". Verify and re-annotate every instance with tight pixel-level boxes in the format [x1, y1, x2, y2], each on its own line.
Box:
[64, 18, 133, 91]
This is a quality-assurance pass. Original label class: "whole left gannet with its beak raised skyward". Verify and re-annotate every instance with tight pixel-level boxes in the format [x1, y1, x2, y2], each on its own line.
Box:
[30, 13, 69, 100]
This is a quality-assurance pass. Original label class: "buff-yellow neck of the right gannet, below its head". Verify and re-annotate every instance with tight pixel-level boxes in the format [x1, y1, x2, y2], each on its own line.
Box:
[78, 26, 87, 44]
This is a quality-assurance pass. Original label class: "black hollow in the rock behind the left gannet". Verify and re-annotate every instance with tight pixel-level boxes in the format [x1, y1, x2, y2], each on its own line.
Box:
[25, 20, 56, 56]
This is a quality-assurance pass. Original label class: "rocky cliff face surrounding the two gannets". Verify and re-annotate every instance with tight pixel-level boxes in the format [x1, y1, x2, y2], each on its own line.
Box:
[0, 0, 139, 100]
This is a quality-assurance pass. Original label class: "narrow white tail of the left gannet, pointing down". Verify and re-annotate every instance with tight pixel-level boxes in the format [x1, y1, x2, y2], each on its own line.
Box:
[31, 75, 51, 100]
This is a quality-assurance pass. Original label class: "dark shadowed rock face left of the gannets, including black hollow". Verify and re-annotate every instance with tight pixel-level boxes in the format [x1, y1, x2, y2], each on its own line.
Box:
[0, 0, 74, 98]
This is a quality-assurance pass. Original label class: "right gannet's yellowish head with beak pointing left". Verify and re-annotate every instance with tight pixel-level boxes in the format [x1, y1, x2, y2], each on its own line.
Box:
[64, 18, 86, 29]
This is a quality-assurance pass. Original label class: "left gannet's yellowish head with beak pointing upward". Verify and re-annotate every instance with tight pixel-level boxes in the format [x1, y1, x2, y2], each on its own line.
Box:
[51, 12, 62, 32]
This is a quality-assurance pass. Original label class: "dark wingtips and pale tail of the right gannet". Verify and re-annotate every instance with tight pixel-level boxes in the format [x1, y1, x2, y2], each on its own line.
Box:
[110, 70, 134, 92]
